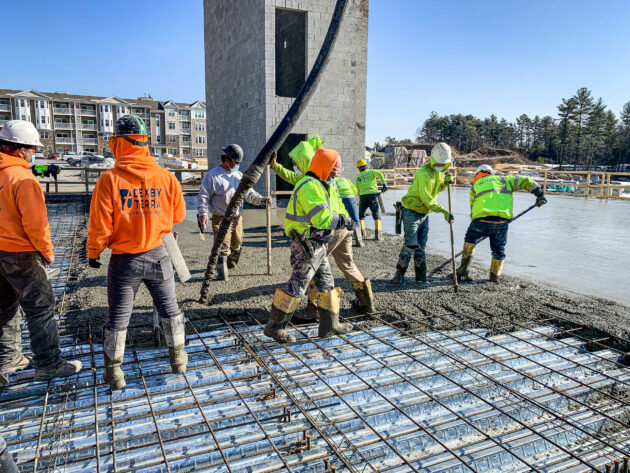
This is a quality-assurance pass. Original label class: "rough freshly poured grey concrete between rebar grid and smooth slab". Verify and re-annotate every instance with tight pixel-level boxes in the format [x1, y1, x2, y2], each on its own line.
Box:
[65, 222, 630, 349]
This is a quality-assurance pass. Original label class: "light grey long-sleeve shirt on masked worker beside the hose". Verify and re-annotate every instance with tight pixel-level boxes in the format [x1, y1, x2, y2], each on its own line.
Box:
[197, 166, 263, 217]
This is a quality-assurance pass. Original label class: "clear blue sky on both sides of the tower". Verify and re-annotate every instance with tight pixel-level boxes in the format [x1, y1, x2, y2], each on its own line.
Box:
[0, 0, 630, 144]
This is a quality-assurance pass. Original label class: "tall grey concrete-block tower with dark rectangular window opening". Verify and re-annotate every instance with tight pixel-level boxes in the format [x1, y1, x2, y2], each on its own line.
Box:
[204, 0, 369, 191]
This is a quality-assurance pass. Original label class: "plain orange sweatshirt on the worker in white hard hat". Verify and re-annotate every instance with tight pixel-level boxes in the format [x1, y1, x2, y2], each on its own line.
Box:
[0, 153, 53, 257]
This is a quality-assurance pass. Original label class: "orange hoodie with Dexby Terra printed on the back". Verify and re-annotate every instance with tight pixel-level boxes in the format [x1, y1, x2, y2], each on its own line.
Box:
[87, 136, 186, 259]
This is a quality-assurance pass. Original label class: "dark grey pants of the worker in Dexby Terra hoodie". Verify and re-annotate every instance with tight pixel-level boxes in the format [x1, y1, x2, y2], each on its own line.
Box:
[107, 246, 180, 330]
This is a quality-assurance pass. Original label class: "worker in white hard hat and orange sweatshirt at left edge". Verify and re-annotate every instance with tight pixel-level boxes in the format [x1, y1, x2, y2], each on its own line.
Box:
[0, 120, 81, 386]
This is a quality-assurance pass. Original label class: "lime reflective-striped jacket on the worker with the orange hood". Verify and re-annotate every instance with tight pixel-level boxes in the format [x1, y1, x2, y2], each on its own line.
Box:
[284, 176, 340, 238]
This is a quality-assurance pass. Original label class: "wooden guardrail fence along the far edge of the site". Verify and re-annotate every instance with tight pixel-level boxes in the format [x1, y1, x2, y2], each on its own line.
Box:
[40, 167, 630, 200]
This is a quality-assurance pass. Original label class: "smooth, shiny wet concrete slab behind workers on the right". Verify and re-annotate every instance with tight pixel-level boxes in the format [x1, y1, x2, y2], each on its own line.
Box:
[366, 187, 630, 305]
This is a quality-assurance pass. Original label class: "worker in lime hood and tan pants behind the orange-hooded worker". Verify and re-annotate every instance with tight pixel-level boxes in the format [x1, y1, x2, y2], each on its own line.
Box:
[270, 140, 374, 321]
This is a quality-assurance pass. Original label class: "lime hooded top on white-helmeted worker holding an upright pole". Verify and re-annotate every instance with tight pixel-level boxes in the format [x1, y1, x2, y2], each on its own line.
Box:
[402, 158, 451, 214]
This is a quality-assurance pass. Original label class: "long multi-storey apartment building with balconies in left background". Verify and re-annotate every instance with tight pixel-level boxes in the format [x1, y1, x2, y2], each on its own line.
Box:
[0, 89, 207, 159]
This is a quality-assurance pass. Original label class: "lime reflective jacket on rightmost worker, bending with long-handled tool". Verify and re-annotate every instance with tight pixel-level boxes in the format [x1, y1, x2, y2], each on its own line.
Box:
[470, 175, 538, 220]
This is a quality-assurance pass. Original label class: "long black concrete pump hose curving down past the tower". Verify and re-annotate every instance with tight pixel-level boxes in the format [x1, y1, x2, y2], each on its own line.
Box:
[199, 0, 348, 304]
